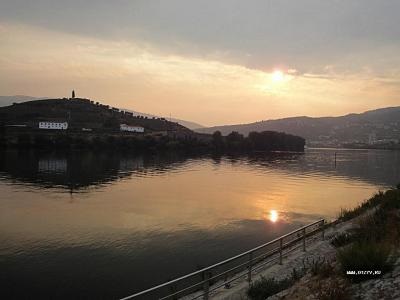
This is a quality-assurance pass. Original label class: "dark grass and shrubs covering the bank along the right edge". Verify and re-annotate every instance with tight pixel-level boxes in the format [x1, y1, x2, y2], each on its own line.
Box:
[332, 189, 400, 282]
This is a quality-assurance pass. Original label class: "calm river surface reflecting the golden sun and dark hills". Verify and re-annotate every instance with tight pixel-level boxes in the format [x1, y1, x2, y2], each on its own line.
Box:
[0, 149, 400, 299]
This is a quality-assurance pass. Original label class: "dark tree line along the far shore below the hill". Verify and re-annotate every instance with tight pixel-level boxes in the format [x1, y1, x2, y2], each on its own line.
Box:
[0, 131, 305, 153]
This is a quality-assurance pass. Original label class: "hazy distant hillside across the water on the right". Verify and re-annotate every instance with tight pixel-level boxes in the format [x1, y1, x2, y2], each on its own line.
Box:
[196, 106, 400, 146]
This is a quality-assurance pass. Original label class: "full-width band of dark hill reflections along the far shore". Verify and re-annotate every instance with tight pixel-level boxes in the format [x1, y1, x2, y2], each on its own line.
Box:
[0, 149, 400, 190]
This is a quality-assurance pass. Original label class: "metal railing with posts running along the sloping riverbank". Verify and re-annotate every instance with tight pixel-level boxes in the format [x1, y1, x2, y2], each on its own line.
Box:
[121, 219, 325, 300]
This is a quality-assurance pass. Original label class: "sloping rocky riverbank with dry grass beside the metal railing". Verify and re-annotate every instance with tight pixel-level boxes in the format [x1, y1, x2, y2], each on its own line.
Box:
[203, 186, 400, 300]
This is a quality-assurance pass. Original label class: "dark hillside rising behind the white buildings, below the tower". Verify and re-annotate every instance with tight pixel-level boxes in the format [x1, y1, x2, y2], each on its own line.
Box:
[0, 98, 192, 134]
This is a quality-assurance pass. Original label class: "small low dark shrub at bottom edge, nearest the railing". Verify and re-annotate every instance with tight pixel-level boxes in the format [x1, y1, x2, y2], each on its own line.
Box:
[247, 277, 293, 300]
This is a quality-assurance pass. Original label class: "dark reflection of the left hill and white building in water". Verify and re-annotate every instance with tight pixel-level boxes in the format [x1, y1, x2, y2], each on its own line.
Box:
[0, 151, 195, 190]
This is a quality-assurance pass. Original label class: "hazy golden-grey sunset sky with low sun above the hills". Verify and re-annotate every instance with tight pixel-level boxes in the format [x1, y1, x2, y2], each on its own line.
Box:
[0, 0, 400, 125]
